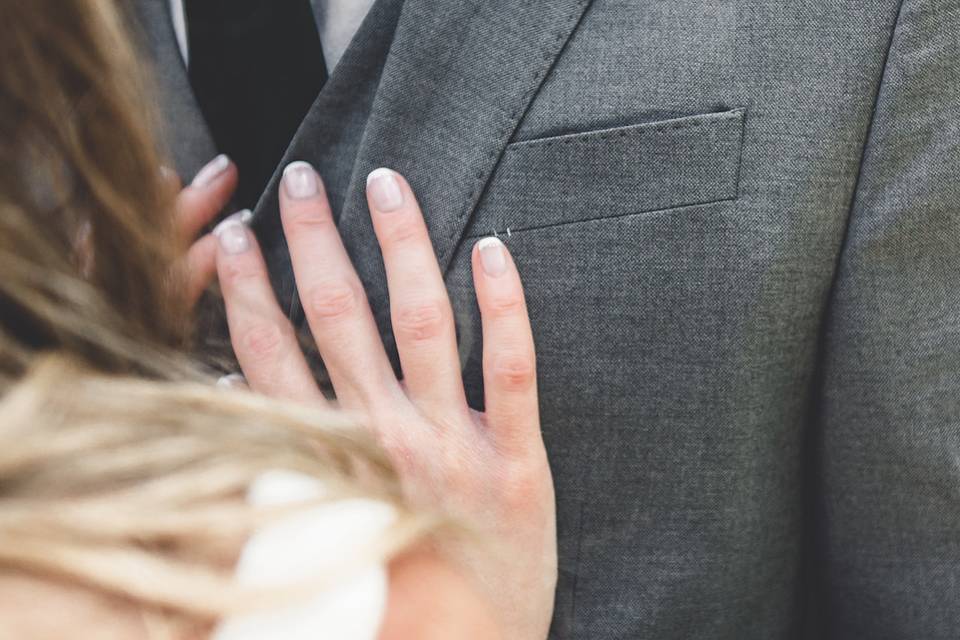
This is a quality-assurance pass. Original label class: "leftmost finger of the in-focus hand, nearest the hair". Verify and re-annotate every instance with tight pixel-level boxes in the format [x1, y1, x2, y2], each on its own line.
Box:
[214, 216, 323, 402]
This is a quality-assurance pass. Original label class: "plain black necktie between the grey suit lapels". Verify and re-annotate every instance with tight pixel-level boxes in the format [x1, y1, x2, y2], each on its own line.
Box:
[185, 0, 327, 208]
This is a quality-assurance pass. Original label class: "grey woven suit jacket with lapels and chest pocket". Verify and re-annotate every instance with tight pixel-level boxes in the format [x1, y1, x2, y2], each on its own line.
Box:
[133, 0, 960, 640]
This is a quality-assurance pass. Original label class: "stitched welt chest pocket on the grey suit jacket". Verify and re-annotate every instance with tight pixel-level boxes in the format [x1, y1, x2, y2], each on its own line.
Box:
[469, 109, 746, 237]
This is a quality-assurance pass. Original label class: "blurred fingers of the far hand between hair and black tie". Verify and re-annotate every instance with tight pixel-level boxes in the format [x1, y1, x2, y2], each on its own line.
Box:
[163, 155, 238, 307]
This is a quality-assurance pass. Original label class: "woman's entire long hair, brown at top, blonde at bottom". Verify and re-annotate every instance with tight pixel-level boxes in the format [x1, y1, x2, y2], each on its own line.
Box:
[0, 0, 435, 632]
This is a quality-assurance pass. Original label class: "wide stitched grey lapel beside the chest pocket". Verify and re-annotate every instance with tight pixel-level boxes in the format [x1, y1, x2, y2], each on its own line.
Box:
[340, 0, 591, 333]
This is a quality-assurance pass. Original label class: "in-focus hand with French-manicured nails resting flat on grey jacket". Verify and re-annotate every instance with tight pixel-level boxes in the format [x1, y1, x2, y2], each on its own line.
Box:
[214, 163, 557, 639]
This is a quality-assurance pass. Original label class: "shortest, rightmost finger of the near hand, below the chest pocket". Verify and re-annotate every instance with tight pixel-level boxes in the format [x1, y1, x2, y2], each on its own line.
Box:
[473, 238, 540, 450]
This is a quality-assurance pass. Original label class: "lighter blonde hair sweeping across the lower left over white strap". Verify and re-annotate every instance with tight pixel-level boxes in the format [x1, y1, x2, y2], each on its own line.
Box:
[0, 356, 437, 619]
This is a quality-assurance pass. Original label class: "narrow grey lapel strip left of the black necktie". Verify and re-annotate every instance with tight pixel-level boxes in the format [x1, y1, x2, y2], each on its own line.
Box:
[134, 0, 216, 181]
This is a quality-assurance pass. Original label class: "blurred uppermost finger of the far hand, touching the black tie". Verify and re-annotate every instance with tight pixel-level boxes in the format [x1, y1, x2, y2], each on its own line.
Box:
[176, 155, 238, 242]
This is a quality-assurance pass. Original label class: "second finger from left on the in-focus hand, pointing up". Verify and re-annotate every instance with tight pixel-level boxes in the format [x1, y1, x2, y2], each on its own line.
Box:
[280, 162, 400, 408]
